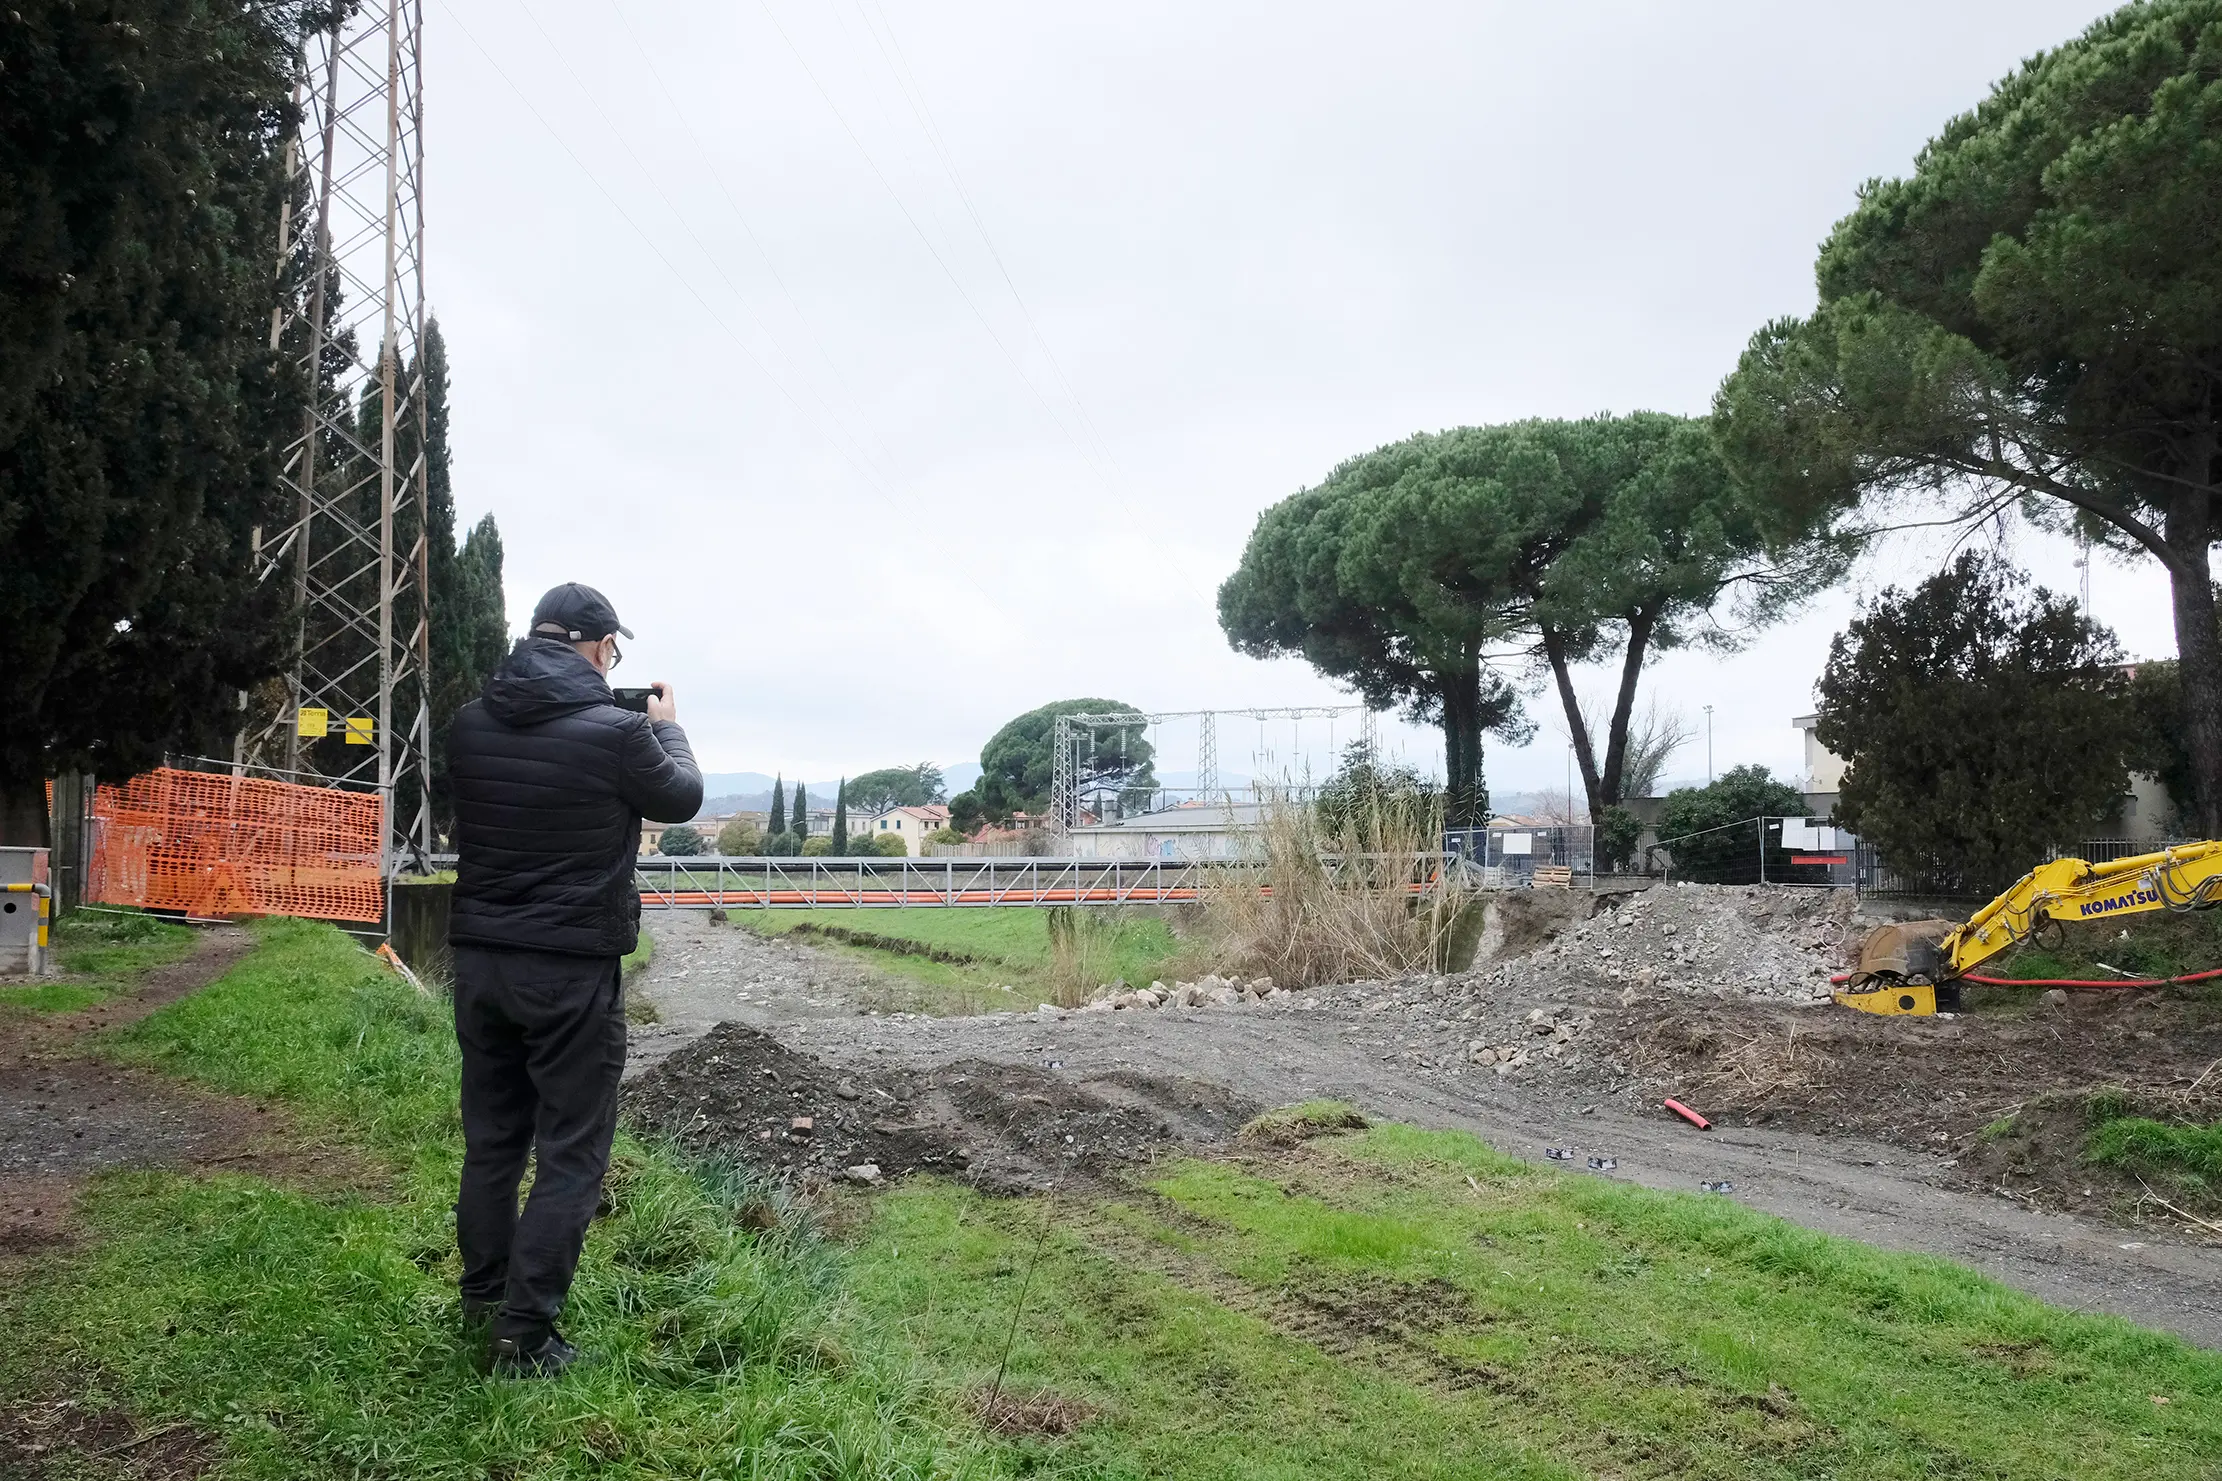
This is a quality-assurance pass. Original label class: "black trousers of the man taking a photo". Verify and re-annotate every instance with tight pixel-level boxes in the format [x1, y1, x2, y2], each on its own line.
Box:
[456, 946, 624, 1337]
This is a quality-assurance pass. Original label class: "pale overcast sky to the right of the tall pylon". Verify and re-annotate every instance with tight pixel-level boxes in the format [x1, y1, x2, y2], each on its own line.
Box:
[427, 0, 2173, 790]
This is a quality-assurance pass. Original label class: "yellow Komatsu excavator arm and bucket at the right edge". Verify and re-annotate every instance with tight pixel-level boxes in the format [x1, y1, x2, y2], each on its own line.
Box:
[1833, 844, 2222, 1015]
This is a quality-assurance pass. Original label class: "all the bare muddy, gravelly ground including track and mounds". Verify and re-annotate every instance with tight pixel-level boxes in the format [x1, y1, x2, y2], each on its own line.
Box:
[627, 890, 2222, 1346]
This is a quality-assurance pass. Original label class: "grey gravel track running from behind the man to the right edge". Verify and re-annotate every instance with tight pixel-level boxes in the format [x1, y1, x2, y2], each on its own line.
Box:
[642, 917, 2222, 1348]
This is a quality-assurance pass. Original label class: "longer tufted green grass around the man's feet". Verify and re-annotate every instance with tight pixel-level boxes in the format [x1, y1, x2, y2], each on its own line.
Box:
[0, 921, 1008, 1479]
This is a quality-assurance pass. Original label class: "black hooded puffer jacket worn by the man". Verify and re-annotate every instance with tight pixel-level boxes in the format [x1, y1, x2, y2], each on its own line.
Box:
[447, 637, 702, 957]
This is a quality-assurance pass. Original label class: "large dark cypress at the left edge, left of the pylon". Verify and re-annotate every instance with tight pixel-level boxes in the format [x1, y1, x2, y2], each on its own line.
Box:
[0, 0, 304, 846]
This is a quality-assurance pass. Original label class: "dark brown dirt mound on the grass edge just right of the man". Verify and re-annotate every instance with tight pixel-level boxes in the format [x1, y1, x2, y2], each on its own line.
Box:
[622, 1024, 1255, 1192]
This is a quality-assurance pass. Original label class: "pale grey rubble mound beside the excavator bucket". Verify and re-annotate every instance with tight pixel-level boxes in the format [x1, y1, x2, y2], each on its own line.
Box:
[1498, 884, 1860, 1004]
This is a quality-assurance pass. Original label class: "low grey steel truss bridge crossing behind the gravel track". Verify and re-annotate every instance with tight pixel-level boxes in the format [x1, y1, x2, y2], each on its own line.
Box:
[633, 855, 1480, 910]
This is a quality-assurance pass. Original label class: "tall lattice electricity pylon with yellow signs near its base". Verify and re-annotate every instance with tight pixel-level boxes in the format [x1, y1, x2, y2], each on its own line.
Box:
[236, 0, 431, 875]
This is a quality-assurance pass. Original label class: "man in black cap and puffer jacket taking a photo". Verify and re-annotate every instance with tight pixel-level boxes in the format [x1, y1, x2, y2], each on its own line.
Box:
[447, 582, 702, 1377]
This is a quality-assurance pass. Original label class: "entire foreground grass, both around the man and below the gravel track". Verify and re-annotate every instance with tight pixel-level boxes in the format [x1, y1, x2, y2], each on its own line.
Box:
[0, 921, 2222, 1481]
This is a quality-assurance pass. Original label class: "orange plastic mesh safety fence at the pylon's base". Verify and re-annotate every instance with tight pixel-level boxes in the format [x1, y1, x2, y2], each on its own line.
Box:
[84, 766, 387, 921]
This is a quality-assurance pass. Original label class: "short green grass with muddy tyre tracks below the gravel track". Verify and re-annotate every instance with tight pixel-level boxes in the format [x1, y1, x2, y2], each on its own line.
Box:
[855, 1126, 2222, 1481]
